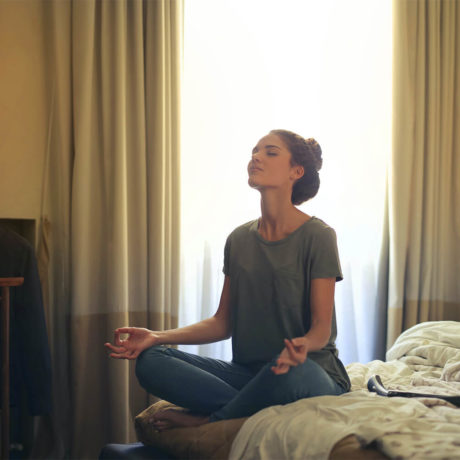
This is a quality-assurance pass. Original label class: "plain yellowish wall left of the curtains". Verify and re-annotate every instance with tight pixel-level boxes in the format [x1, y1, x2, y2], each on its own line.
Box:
[0, 0, 48, 230]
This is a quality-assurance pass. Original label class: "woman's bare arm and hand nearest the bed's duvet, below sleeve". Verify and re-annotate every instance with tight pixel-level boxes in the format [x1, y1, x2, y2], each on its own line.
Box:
[272, 278, 335, 374]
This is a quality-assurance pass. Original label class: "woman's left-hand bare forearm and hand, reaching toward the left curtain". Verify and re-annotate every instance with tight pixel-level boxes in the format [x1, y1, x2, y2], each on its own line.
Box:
[105, 276, 231, 359]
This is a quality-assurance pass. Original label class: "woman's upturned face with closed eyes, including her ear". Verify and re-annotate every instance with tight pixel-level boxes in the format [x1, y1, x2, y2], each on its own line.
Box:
[248, 134, 303, 190]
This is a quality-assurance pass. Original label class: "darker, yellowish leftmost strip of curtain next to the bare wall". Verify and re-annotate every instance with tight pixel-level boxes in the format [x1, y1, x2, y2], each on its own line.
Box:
[34, 0, 74, 459]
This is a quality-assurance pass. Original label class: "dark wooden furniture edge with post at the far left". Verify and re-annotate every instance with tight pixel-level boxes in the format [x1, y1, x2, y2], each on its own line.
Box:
[0, 278, 24, 459]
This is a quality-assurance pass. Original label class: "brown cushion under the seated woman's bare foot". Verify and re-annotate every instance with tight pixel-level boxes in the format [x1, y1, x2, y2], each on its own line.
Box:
[134, 401, 247, 460]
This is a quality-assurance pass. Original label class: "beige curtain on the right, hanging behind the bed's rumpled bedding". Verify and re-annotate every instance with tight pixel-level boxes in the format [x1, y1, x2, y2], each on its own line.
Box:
[387, 0, 460, 346]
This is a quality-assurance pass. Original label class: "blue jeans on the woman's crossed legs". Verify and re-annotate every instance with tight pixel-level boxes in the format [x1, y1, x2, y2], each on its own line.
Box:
[136, 346, 345, 422]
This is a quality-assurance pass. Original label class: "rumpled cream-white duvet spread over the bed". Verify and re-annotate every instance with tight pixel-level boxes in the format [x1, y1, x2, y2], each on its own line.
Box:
[230, 321, 460, 460]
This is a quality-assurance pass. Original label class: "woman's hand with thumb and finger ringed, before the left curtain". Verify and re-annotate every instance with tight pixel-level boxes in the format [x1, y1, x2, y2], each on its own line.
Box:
[104, 327, 160, 359]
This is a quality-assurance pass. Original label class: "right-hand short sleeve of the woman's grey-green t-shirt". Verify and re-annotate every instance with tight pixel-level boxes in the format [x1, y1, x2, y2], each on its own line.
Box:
[310, 227, 343, 281]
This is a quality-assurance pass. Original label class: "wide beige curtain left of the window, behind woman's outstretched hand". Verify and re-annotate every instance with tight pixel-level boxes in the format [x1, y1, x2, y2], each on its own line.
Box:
[37, 0, 183, 459]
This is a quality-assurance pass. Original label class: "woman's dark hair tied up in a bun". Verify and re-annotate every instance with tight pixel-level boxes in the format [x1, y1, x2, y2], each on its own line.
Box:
[270, 129, 323, 205]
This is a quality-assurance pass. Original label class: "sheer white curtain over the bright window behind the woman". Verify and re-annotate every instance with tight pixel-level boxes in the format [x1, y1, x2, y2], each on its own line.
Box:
[179, 0, 392, 363]
